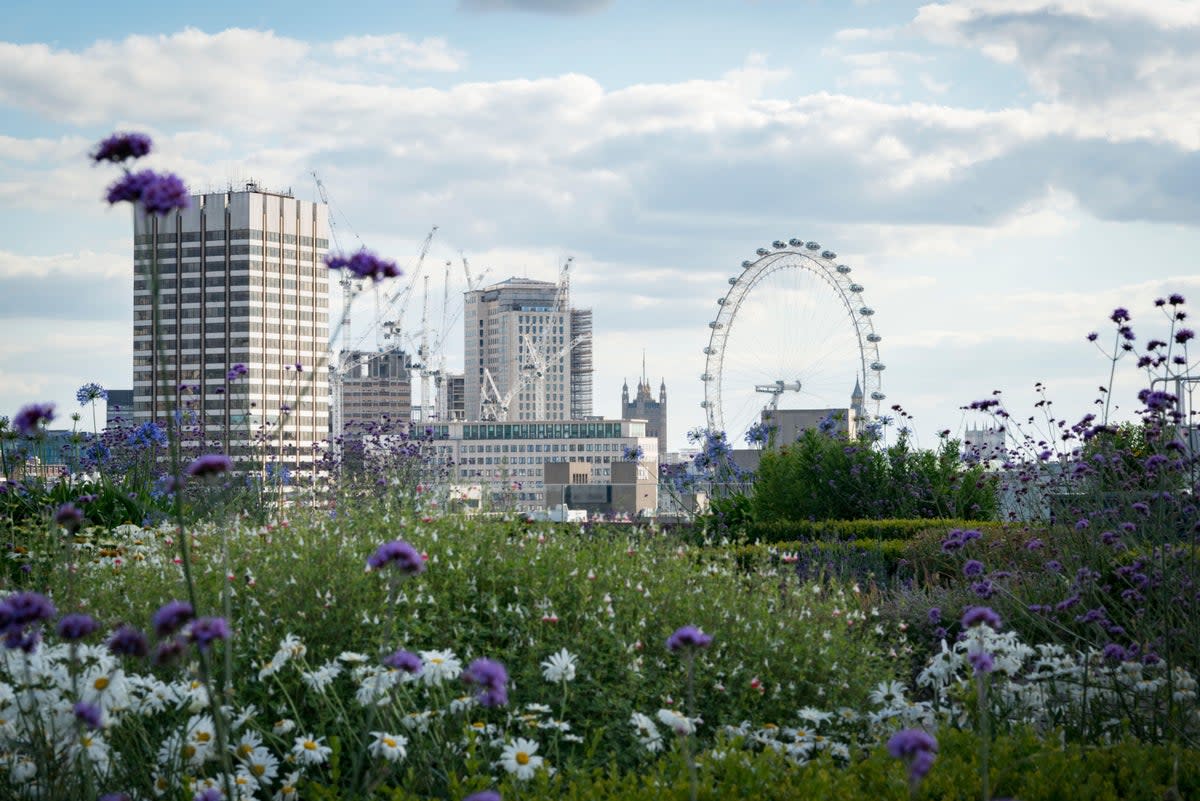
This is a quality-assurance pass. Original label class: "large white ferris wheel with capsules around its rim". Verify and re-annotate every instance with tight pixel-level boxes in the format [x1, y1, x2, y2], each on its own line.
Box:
[701, 239, 886, 446]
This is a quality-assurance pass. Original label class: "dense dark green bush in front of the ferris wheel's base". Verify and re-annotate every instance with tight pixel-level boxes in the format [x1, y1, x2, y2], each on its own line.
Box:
[752, 429, 997, 522]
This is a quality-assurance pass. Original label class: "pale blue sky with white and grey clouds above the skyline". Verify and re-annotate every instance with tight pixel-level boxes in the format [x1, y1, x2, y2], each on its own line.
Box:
[0, 0, 1200, 448]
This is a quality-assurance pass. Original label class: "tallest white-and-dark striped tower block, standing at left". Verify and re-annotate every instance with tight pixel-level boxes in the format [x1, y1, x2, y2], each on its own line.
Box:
[133, 183, 329, 464]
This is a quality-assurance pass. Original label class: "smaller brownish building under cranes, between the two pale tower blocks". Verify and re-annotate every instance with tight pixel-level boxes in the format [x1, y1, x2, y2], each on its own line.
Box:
[342, 350, 413, 432]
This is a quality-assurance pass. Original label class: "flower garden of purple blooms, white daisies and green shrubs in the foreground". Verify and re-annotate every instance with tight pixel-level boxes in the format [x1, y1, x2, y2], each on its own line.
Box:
[0, 134, 1200, 801]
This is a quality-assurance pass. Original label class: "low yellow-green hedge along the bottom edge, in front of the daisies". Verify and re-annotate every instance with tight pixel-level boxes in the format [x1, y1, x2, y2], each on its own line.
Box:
[343, 731, 1200, 801]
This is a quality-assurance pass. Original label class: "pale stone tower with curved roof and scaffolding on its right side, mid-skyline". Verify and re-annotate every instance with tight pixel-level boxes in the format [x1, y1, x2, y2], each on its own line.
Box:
[463, 278, 592, 421]
